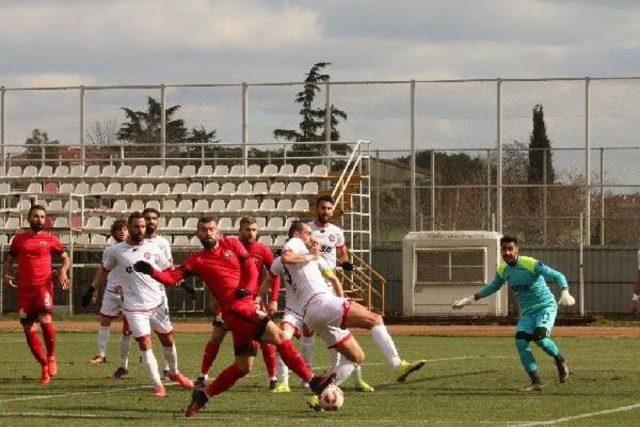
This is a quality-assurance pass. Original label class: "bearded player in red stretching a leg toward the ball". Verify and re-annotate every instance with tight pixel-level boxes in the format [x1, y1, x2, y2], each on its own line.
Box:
[134, 218, 333, 417]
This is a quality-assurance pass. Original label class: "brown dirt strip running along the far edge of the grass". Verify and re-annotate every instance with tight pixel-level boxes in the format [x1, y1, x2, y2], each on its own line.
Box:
[0, 319, 640, 338]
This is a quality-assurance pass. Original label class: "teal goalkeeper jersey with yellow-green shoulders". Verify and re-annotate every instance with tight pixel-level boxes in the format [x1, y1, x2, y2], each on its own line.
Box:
[476, 256, 569, 314]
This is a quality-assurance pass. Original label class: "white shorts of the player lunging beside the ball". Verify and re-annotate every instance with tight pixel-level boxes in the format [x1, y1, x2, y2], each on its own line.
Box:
[303, 294, 352, 348]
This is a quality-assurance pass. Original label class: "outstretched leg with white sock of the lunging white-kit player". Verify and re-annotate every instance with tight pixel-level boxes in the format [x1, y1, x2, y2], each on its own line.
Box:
[343, 301, 426, 382]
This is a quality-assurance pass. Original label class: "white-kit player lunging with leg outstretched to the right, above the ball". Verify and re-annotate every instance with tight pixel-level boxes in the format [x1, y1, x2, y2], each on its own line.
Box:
[272, 221, 426, 407]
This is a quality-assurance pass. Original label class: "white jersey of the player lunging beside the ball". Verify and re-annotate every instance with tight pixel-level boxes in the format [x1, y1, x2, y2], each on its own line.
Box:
[271, 237, 331, 315]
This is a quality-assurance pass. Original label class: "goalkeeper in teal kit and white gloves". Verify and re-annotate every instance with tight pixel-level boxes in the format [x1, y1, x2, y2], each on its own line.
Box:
[453, 236, 575, 392]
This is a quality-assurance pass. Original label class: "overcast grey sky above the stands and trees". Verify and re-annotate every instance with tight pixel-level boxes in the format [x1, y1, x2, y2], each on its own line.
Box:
[0, 0, 640, 179]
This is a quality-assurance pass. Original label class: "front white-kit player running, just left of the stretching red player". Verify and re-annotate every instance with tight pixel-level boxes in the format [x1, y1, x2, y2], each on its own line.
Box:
[102, 212, 193, 397]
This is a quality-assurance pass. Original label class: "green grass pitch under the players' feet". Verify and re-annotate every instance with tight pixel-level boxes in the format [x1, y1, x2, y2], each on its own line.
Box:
[0, 332, 640, 426]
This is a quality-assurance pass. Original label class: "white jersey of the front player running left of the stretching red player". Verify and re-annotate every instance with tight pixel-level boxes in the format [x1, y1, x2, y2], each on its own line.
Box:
[102, 239, 171, 311]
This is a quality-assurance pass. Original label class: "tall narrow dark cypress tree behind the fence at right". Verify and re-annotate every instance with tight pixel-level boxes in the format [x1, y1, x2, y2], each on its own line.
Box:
[529, 104, 555, 184]
